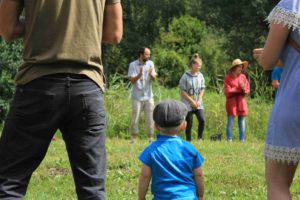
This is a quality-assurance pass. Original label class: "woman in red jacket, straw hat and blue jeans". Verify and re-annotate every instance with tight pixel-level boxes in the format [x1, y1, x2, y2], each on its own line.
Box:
[224, 59, 250, 142]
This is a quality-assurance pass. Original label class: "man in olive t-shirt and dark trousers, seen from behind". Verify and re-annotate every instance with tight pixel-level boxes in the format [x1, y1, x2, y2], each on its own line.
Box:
[0, 0, 123, 200]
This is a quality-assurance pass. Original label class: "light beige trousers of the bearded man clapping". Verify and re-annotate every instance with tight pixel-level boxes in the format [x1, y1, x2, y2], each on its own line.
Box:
[131, 98, 154, 136]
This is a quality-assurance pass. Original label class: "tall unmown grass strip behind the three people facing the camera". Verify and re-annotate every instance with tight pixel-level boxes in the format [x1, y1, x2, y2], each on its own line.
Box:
[105, 85, 273, 140]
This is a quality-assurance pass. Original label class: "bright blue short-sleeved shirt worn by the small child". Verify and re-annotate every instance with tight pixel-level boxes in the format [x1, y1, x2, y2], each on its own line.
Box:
[139, 135, 204, 200]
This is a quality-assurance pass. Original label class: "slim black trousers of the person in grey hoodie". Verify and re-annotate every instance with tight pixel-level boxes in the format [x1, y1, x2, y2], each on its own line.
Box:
[185, 109, 205, 141]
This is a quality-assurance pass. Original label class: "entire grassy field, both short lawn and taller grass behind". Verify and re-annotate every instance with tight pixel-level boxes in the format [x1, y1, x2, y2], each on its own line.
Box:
[2, 85, 300, 200]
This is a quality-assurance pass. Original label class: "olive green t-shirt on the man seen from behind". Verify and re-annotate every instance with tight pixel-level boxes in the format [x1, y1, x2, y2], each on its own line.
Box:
[16, 0, 120, 90]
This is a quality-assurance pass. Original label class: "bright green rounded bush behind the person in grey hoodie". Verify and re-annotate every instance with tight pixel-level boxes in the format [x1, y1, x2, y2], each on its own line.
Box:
[154, 16, 227, 88]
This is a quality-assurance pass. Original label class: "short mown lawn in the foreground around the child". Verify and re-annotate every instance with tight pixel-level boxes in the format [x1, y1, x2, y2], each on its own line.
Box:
[26, 136, 300, 200]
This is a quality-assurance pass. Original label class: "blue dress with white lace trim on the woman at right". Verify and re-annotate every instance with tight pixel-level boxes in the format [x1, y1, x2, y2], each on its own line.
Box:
[265, 0, 300, 163]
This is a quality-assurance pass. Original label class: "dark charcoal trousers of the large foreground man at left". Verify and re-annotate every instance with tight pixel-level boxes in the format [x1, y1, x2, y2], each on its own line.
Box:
[0, 74, 106, 200]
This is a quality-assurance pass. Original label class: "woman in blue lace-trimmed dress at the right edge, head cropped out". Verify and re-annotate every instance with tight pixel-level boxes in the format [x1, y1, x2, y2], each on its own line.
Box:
[253, 0, 300, 200]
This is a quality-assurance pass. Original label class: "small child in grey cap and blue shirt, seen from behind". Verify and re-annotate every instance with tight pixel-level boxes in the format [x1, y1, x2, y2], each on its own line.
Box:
[138, 100, 204, 200]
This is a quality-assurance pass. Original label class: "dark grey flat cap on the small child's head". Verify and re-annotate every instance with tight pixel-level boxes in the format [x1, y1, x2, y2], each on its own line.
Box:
[153, 99, 188, 128]
